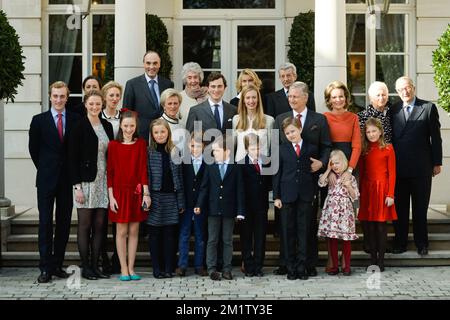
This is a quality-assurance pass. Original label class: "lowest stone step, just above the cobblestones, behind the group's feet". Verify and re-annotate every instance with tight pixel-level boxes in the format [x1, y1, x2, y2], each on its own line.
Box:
[2, 250, 450, 272]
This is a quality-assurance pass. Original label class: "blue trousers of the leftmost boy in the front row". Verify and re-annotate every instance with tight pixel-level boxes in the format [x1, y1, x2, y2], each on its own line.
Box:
[178, 208, 205, 270]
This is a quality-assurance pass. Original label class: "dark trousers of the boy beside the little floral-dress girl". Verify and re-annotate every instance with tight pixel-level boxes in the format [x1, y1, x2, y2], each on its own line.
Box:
[280, 199, 313, 273]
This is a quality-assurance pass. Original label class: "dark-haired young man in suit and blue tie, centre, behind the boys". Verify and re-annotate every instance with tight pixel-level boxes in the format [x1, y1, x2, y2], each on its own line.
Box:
[186, 72, 237, 134]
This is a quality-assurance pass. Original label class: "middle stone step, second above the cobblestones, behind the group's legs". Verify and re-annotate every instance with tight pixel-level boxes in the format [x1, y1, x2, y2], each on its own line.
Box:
[6, 233, 450, 252]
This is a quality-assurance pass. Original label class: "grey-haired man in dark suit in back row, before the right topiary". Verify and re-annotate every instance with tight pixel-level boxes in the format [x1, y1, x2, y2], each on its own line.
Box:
[266, 62, 316, 119]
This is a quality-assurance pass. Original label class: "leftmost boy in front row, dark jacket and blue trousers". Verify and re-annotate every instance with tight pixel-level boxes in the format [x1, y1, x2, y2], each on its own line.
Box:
[176, 132, 208, 277]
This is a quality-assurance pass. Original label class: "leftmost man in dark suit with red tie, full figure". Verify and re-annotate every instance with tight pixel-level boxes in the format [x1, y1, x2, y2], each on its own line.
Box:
[28, 81, 80, 283]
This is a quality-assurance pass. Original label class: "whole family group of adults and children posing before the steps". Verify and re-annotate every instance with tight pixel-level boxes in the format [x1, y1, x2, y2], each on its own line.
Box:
[29, 51, 442, 283]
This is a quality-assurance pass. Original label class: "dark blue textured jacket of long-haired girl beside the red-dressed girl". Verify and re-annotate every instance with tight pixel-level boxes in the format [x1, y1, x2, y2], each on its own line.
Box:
[147, 149, 185, 209]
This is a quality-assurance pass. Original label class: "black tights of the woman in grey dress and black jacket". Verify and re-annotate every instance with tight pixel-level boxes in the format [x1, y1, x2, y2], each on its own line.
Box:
[77, 208, 106, 269]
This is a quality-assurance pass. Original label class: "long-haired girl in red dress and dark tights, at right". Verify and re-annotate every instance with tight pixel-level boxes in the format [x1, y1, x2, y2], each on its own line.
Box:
[358, 118, 397, 272]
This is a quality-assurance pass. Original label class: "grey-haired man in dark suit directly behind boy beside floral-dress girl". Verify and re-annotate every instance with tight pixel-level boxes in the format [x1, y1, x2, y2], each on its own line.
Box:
[274, 81, 332, 276]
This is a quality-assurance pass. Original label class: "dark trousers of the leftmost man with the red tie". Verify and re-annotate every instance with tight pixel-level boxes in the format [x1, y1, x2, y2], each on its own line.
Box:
[37, 181, 73, 272]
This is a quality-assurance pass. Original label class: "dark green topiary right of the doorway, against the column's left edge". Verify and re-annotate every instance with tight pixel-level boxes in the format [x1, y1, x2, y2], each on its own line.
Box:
[288, 11, 314, 92]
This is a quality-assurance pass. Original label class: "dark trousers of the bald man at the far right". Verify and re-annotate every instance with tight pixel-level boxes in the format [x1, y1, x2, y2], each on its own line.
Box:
[393, 176, 432, 249]
